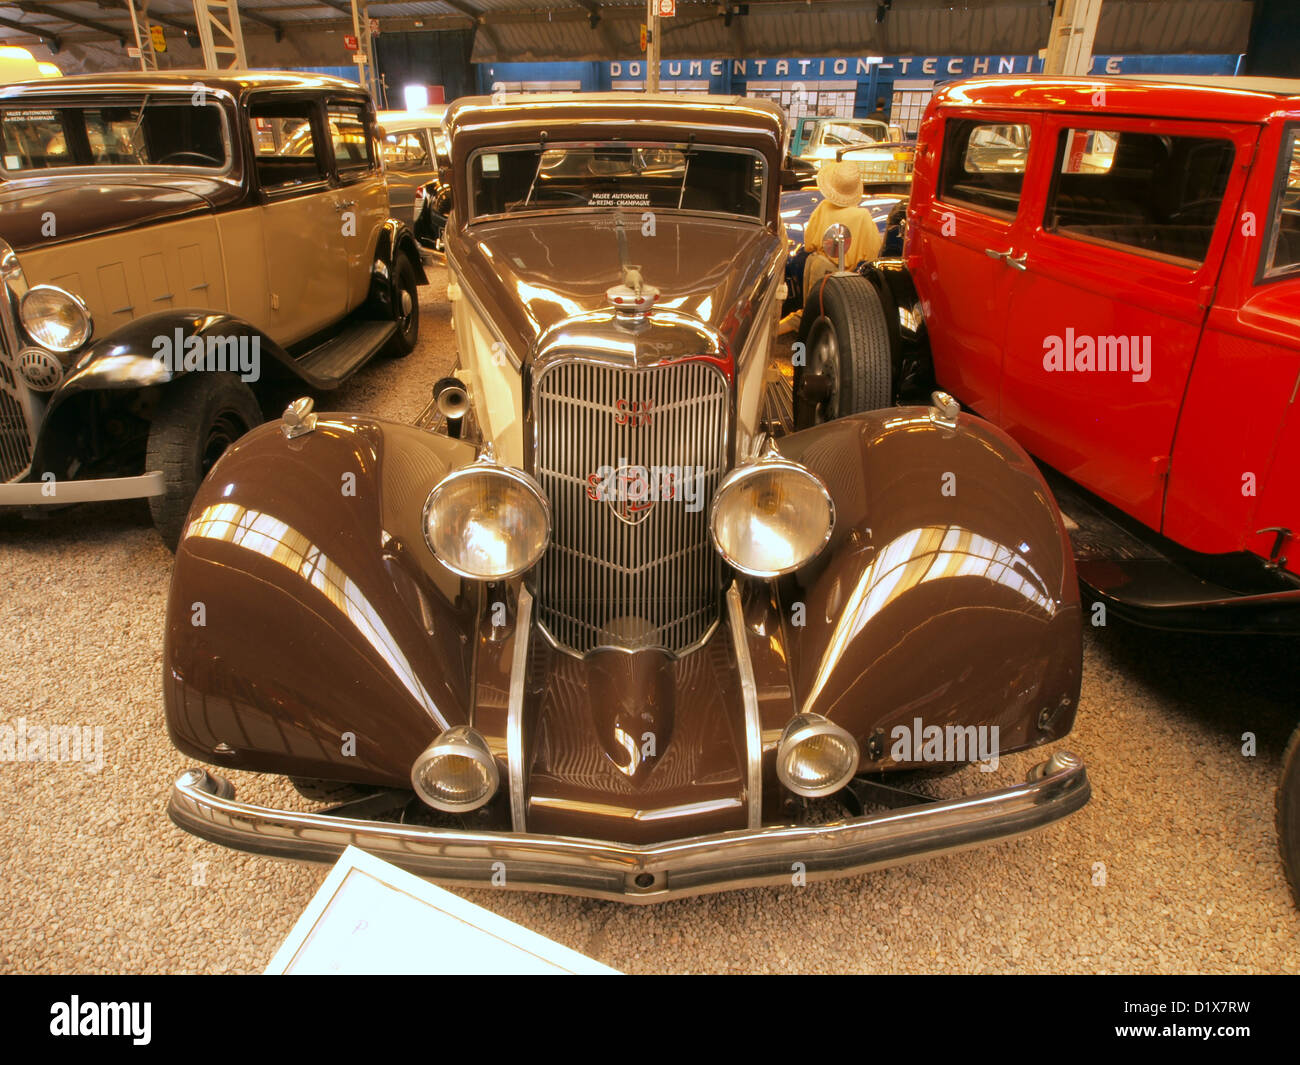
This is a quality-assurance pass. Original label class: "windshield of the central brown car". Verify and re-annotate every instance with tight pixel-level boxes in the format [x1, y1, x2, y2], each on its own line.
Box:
[469, 144, 766, 218]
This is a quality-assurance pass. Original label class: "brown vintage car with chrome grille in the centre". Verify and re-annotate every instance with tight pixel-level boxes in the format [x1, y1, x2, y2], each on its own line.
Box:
[164, 95, 1089, 902]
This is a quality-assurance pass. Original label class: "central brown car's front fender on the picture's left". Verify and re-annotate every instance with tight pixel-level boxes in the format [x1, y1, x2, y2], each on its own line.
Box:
[163, 415, 477, 787]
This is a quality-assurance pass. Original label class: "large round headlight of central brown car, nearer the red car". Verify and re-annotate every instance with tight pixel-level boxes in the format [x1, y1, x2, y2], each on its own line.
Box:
[709, 459, 835, 577]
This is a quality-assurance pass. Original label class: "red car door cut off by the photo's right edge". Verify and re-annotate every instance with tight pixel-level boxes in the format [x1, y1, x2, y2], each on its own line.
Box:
[1164, 122, 1300, 573]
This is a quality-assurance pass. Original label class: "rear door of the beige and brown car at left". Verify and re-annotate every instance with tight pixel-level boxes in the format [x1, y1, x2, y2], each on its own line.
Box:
[326, 98, 389, 311]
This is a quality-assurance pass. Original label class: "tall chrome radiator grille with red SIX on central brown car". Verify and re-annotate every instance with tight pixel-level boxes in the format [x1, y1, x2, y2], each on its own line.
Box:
[533, 360, 729, 654]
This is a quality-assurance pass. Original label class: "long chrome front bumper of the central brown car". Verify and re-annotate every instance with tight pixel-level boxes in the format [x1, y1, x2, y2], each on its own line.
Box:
[168, 752, 1091, 902]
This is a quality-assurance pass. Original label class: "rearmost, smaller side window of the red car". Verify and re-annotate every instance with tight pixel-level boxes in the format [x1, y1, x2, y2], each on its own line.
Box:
[939, 118, 1030, 215]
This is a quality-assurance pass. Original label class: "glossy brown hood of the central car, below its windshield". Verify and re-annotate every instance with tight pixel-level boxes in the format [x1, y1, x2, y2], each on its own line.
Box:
[447, 212, 784, 360]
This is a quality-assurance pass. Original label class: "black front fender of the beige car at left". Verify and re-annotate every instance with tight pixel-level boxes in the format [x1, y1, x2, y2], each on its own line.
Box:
[33, 309, 296, 476]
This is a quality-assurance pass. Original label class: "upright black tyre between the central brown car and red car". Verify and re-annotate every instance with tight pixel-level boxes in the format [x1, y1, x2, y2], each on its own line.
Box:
[794, 274, 893, 429]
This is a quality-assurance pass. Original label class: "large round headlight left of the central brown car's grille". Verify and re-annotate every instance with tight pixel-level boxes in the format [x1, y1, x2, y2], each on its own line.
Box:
[424, 460, 551, 580]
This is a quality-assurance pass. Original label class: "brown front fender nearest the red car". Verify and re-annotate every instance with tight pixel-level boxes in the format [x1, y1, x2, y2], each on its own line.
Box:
[780, 407, 1083, 767]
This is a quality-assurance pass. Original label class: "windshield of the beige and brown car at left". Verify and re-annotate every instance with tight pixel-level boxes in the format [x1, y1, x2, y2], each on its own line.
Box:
[0, 94, 226, 174]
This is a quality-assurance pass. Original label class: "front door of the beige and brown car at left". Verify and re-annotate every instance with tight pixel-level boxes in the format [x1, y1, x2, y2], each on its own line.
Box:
[245, 92, 347, 346]
